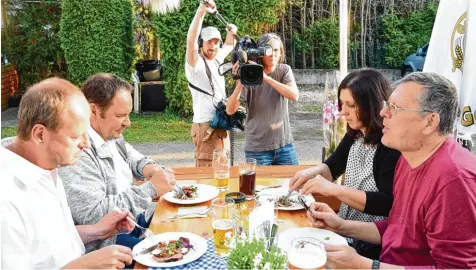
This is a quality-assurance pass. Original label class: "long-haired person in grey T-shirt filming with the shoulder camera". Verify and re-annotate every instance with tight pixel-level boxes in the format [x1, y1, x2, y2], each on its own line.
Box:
[226, 33, 299, 165]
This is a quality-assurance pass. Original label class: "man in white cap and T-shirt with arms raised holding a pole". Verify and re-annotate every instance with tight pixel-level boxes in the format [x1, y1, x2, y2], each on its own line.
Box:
[185, 0, 237, 167]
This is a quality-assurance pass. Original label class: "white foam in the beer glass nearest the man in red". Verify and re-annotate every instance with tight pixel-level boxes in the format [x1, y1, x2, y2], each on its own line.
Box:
[288, 247, 327, 269]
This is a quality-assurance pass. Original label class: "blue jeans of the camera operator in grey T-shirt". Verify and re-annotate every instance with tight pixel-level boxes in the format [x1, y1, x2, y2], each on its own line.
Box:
[245, 144, 299, 166]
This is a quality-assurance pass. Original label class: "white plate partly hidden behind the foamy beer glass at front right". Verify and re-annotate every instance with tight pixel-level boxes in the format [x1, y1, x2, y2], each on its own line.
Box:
[278, 227, 348, 252]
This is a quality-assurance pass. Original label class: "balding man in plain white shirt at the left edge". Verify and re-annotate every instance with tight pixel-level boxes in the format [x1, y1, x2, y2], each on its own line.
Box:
[0, 78, 133, 269]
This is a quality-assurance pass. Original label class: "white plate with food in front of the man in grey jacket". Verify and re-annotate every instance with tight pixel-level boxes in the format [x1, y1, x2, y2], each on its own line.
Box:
[163, 184, 220, 204]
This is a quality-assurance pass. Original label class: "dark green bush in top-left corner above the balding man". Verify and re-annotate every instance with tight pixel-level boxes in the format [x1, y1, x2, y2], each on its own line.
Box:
[2, 0, 66, 90]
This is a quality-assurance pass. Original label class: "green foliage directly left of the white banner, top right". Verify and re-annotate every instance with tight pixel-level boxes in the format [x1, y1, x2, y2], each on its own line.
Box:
[382, 5, 437, 68]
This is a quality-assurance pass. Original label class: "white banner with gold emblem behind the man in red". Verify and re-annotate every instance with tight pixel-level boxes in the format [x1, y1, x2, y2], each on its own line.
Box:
[423, 0, 476, 135]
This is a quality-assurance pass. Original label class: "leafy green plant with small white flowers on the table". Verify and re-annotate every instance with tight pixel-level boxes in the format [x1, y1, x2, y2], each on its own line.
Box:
[227, 238, 287, 269]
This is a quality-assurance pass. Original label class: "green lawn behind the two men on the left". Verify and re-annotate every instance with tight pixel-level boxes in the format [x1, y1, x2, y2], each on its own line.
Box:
[1, 113, 192, 143]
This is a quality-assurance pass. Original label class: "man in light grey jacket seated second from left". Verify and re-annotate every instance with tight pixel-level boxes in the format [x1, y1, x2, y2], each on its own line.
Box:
[59, 74, 175, 252]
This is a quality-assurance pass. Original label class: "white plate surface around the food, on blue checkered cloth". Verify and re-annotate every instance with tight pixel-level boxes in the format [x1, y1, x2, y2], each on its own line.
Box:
[132, 232, 207, 267]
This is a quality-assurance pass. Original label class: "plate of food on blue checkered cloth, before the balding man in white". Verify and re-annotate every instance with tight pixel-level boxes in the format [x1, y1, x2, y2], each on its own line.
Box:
[132, 232, 207, 267]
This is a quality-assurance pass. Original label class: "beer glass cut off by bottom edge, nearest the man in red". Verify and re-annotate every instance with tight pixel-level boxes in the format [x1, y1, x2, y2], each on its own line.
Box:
[288, 237, 327, 269]
